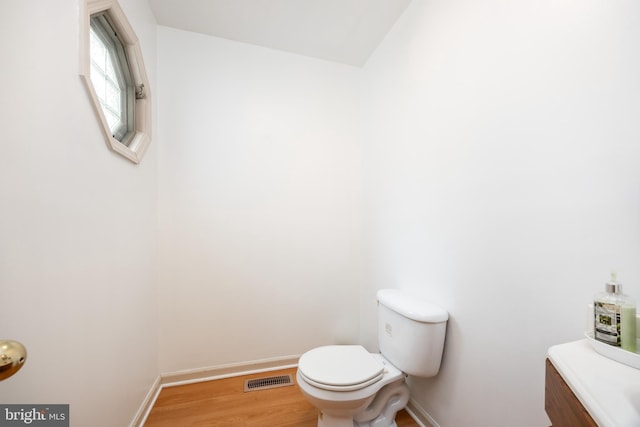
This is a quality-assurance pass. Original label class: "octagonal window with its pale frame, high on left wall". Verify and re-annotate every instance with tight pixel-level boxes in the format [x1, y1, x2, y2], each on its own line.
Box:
[80, 0, 151, 163]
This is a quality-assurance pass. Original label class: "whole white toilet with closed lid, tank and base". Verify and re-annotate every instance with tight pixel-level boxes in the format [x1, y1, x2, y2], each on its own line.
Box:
[297, 289, 449, 427]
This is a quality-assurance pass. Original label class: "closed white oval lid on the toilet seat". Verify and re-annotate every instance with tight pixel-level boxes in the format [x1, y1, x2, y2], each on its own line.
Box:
[298, 345, 384, 391]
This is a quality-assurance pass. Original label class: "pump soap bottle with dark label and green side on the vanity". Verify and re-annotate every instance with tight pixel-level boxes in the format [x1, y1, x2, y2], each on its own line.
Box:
[593, 272, 636, 352]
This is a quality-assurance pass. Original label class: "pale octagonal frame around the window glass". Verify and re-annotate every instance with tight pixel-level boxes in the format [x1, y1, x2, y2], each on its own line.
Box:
[80, 0, 151, 164]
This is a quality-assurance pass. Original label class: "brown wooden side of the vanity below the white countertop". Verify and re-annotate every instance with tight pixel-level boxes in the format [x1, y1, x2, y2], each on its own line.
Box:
[544, 359, 598, 427]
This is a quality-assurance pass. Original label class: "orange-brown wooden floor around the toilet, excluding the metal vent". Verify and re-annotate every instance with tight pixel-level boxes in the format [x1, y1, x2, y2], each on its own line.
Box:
[144, 368, 418, 427]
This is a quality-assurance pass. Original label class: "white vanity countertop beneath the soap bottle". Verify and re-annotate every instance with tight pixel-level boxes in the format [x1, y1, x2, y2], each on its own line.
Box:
[548, 339, 640, 427]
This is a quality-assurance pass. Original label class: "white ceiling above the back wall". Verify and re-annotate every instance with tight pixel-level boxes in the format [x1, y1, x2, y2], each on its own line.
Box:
[149, 0, 411, 66]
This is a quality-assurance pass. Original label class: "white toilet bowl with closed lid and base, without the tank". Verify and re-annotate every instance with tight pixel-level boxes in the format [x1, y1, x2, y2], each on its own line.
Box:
[297, 345, 409, 427]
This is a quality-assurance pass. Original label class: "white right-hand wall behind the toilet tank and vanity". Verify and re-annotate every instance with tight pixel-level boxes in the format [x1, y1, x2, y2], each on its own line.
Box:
[362, 0, 640, 427]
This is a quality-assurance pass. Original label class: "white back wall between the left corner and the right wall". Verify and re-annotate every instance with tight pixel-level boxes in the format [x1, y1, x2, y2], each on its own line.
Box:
[158, 27, 361, 372]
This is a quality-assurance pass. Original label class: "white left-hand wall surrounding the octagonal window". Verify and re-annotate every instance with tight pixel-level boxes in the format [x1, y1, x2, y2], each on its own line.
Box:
[0, 0, 157, 427]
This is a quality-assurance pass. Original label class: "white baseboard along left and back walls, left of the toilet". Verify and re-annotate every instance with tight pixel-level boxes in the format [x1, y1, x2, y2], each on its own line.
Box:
[130, 356, 300, 427]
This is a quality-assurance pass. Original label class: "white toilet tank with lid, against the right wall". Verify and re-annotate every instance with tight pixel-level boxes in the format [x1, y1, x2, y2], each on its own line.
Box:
[377, 289, 449, 378]
